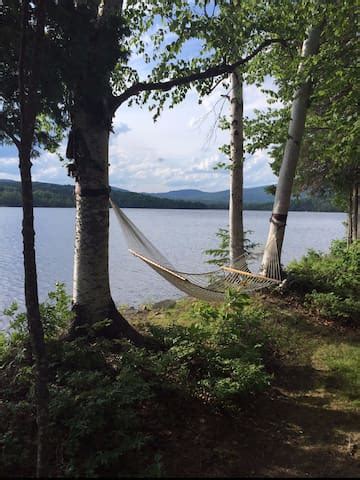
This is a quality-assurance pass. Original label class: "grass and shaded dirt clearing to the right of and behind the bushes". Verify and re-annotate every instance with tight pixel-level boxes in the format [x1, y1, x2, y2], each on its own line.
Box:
[125, 296, 360, 477]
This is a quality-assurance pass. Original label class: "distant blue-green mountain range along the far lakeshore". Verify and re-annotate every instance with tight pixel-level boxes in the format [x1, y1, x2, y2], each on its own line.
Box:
[0, 180, 339, 211]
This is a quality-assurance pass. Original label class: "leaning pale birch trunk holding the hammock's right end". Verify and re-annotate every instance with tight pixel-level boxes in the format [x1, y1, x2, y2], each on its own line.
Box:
[262, 26, 321, 275]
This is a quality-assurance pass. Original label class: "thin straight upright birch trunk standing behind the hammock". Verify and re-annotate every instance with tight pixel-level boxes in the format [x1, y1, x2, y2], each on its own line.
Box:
[229, 71, 244, 266]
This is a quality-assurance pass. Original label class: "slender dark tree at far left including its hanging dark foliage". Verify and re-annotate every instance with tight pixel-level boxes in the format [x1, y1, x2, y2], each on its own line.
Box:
[0, 0, 64, 477]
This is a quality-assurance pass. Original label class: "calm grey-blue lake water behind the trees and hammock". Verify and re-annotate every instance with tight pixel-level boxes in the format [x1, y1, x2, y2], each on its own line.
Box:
[0, 207, 345, 322]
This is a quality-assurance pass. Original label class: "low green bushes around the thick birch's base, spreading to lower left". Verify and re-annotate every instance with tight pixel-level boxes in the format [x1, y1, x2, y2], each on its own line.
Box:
[0, 285, 270, 477]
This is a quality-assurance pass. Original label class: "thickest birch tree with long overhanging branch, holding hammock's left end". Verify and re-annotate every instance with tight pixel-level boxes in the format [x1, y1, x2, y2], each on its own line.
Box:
[44, 0, 290, 345]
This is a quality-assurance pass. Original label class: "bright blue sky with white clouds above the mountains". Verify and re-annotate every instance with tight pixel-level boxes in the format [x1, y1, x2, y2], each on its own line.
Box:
[0, 21, 276, 193]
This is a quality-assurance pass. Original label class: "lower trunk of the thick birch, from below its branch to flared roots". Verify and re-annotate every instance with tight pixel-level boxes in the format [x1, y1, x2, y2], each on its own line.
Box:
[67, 110, 145, 346]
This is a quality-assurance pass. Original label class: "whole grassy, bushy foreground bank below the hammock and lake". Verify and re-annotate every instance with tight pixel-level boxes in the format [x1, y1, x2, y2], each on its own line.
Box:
[0, 282, 360, 477]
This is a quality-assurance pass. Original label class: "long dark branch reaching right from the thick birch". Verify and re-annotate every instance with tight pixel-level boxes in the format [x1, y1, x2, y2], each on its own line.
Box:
[111, 39, 286, 114]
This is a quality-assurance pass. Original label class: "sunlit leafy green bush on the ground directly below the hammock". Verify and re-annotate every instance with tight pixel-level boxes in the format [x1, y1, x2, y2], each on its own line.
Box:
[146, 292, 270, 407]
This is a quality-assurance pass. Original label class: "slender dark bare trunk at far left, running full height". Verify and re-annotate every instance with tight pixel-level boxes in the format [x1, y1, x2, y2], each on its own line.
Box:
[18, 0, 49, 477]
